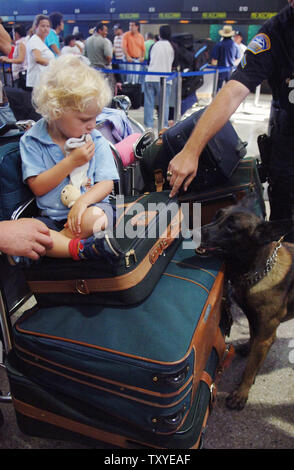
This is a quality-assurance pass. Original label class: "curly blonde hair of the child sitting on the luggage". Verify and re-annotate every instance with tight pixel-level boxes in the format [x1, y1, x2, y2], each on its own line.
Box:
[32, 54, 112, 121]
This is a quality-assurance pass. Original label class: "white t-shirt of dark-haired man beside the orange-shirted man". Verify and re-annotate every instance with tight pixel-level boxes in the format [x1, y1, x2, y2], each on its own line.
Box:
[145, 39, 175, 82]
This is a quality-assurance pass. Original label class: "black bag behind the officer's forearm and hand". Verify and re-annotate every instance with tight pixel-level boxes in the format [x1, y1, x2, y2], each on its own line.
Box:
[141, 109, 247, 191]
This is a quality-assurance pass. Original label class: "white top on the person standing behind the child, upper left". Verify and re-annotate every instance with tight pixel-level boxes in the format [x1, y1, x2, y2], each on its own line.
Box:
[27, 34, 55, 87]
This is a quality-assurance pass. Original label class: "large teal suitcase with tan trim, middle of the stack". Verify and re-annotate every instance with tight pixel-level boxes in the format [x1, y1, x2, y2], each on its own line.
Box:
[5, 242, 233, 447]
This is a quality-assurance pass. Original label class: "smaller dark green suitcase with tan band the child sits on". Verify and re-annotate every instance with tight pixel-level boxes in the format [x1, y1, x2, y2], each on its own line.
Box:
[24, 191, 183, 305]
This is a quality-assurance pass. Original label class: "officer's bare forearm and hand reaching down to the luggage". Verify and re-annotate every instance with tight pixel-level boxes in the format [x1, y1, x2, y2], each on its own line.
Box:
[168, 80, 250, 197]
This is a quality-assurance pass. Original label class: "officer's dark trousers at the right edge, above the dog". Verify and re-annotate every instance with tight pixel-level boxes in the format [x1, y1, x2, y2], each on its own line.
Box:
[268, 134, 294, 243]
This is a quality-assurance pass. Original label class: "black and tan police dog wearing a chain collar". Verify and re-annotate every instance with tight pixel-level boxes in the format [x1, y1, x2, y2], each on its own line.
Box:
[201, 194, 294, 410]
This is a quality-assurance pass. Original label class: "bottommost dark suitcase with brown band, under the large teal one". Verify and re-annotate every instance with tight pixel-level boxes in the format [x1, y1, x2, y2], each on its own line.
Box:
[5, 349, 222, 449]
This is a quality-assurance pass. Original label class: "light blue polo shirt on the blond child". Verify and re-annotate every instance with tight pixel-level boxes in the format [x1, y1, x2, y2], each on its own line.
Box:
[20, 119, 119, 220]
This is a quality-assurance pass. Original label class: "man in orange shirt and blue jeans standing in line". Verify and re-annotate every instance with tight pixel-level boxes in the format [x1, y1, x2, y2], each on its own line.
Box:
[123, 21, 145, 83]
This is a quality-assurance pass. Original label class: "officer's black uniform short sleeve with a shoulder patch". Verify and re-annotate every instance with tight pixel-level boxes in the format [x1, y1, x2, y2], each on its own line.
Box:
[231, 35, 273, 93]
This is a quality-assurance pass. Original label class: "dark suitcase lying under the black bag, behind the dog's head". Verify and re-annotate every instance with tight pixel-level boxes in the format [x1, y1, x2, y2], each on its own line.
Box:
[179, 157, 266, 228]
